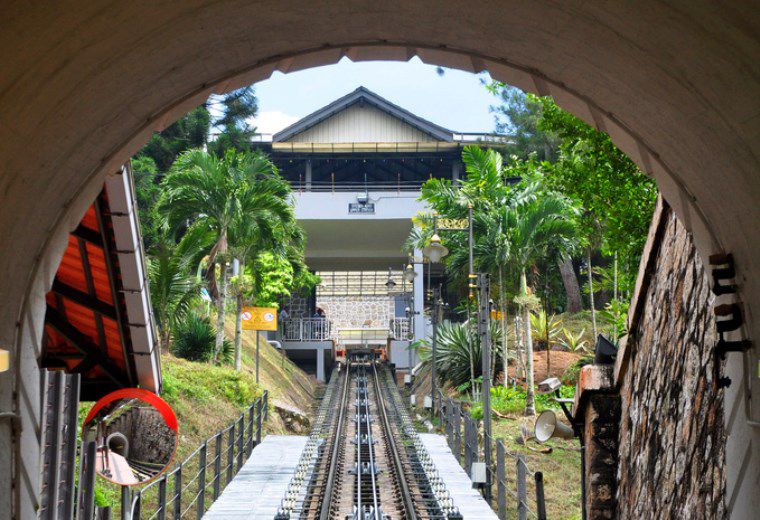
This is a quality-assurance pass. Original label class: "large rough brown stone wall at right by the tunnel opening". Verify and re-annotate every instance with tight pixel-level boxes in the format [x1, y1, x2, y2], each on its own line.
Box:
[617, 209, 726, 519]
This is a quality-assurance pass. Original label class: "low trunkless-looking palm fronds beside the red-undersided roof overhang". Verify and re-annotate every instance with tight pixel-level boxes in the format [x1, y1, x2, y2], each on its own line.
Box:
[147, 222, 213, 351]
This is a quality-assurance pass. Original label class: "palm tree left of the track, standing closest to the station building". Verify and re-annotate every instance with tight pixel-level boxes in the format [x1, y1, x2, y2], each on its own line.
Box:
[229, 153, 302, 370]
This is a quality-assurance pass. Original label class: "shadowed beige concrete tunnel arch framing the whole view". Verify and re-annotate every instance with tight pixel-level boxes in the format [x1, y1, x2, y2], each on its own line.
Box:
[0, 0, 760, 507]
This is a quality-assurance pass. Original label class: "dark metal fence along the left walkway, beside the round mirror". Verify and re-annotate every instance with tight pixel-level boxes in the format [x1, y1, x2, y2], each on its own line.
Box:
[99, 391, 269, 520]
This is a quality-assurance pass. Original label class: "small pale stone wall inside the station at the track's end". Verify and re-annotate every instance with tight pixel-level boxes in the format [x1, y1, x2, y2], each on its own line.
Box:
[317, 296, 394, 331]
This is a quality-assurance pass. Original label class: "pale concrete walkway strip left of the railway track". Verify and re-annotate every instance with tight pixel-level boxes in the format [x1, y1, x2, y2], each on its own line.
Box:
[203, 435, 307, 520]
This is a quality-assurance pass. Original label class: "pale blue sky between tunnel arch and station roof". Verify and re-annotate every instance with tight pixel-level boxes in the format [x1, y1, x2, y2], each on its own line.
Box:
[251, 57, 496, 133]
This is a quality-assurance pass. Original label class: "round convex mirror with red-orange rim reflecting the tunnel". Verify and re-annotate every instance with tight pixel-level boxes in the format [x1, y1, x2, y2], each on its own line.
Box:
[82, 388, 178, 486]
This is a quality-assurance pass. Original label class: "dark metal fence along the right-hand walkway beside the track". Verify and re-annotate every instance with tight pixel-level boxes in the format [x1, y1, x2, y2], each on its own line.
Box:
[436, 390, 546, 520]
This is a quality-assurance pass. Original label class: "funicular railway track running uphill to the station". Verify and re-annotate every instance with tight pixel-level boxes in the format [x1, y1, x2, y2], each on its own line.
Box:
[275, 354, 462, 520]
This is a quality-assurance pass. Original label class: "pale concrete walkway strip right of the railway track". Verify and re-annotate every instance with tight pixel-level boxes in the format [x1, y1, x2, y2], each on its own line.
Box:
[419, 433, 498, 520]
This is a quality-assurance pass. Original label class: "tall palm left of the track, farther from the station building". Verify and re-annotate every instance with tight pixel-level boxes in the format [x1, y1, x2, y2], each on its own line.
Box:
[159, 149, 252, 363]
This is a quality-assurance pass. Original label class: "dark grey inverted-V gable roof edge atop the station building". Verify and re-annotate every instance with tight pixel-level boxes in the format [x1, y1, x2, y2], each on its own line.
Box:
[272, 87, 454, 142]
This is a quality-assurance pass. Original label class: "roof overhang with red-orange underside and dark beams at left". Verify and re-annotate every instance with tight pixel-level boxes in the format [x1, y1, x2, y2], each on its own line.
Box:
[40, 167, 161, 400]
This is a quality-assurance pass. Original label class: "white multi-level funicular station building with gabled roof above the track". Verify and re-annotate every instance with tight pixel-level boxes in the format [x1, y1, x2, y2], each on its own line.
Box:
[252, 87, 504, 379]
